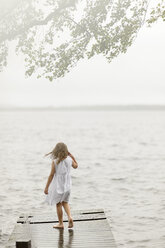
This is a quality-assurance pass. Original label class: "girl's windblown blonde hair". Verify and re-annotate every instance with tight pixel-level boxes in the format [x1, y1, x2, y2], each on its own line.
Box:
[45, 142, 68, 164]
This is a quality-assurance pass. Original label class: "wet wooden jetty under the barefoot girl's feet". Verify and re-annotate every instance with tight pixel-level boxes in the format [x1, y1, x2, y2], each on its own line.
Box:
[6, 209, 116, 248]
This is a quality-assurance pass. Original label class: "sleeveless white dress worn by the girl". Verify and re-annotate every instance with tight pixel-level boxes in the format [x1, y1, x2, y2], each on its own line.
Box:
[45, 156, 72, 205]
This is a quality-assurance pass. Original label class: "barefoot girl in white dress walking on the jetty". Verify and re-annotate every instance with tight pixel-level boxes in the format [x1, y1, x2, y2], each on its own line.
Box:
[44, 142, 78, 229]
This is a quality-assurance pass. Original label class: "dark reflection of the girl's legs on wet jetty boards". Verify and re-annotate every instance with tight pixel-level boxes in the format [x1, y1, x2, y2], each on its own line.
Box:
[58, 229, 74, 248]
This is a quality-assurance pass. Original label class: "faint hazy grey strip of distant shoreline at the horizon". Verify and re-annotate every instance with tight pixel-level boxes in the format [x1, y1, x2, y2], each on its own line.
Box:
[0, 105, 165, 111]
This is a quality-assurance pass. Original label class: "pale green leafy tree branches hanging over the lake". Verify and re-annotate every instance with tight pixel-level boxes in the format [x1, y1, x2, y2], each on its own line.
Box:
[0, 0, 164, 81]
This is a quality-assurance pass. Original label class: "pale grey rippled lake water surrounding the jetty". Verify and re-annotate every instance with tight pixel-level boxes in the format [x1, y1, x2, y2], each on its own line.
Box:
[0, 111, 165, 248]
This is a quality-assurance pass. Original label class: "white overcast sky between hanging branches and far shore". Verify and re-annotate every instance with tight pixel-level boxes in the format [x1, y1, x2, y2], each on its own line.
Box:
[0, 21, 165, 107]
